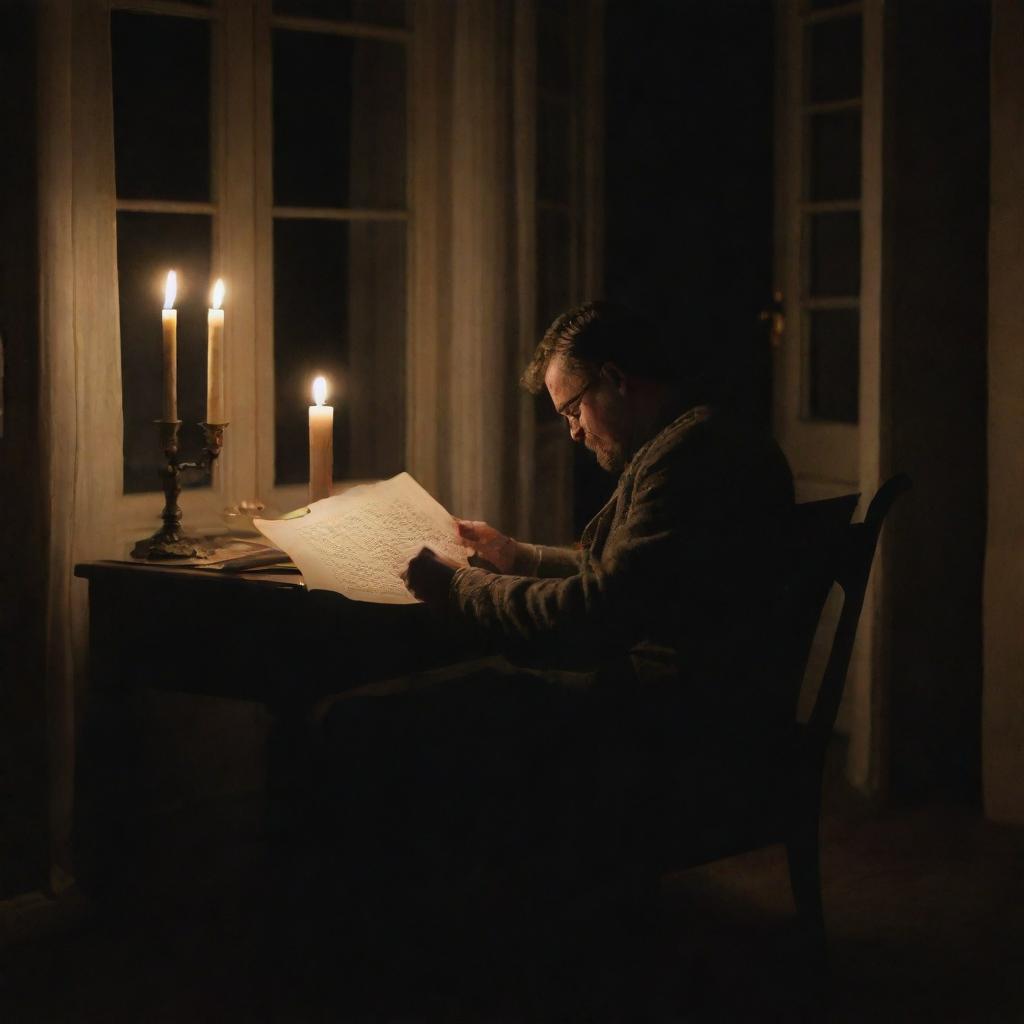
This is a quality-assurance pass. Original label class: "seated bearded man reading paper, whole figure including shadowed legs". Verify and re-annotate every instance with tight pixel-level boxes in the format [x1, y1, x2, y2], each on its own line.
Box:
[311, 302, 793, 1011]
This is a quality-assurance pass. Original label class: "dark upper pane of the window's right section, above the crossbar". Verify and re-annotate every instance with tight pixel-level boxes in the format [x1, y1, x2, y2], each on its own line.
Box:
[273, 31, 406, 209]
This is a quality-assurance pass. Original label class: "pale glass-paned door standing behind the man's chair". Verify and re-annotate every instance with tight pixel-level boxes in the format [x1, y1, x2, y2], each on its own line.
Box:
[773, 0, 882, 774]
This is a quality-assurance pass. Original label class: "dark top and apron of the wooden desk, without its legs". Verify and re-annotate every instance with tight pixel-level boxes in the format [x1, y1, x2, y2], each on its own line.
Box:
[75, 562, 459, 709]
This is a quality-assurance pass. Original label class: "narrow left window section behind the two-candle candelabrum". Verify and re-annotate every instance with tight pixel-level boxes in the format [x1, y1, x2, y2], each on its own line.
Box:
[111, 10, 217, 494]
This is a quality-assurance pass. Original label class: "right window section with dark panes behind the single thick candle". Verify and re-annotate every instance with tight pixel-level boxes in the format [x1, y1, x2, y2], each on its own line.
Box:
[271, 14, 407, 485]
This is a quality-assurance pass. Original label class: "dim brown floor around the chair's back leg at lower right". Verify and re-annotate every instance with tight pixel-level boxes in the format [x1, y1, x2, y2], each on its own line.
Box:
[667, 806, 1024, 1024]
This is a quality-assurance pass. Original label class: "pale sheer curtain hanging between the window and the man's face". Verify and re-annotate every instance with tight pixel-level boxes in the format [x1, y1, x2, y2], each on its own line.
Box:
[407, 0, 544, 531]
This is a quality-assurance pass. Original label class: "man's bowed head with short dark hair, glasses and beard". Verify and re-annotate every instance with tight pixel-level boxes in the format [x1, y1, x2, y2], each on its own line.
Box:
[522, 302, 677, 472]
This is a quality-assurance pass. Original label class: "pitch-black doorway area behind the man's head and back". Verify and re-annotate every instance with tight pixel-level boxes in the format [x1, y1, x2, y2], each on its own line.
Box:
[577, 0, 773, 525]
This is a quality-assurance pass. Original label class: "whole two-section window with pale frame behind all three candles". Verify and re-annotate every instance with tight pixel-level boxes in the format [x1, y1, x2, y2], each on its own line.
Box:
[111, 0, 411, 528]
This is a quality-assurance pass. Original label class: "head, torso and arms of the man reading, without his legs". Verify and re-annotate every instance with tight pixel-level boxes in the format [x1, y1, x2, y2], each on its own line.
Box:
[404, 302, 793, 716]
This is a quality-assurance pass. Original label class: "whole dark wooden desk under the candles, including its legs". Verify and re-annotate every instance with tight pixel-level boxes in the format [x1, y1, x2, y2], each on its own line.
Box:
[74, 562, 459, 895]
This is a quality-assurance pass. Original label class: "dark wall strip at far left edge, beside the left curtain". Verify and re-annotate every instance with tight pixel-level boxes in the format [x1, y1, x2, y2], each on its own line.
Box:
[0, 0, 47, 899]
